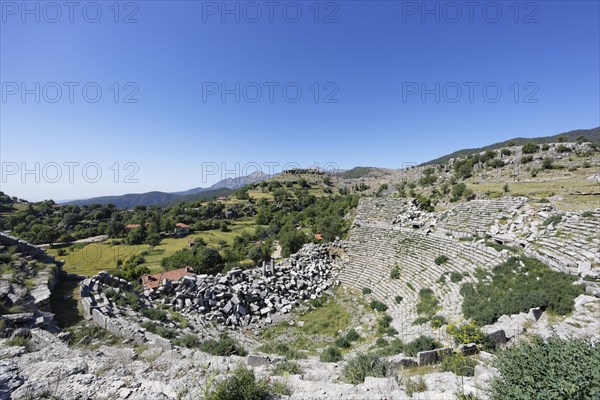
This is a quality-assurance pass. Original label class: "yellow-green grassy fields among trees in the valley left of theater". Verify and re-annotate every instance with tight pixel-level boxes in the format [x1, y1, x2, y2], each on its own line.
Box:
[47, 219, 257, 276]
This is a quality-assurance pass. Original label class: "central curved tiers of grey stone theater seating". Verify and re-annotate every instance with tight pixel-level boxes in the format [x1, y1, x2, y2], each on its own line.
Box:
[339, 198, 507, 340]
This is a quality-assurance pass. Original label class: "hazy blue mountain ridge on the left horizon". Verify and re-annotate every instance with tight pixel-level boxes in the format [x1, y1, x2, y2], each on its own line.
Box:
[63, 172, 269, 209]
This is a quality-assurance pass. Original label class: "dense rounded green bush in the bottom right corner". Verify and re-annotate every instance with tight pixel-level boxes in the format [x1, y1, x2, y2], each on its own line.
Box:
[490, 337, 600, 400]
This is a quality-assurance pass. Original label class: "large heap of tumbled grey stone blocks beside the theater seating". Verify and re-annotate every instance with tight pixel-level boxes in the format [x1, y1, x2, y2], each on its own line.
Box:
[145, 241, 345, 326]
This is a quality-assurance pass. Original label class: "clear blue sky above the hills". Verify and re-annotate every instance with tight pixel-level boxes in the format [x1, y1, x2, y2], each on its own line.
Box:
[0, 1, 600, 200]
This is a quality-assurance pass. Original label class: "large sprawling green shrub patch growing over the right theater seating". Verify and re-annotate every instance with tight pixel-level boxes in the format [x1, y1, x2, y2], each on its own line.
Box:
[460, 257, 584, 325]
